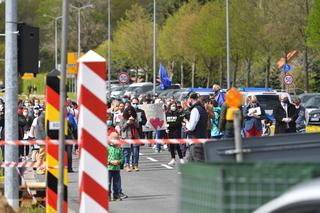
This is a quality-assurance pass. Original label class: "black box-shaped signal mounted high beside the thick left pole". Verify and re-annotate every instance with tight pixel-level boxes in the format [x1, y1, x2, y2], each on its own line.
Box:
[18, 23, 39, 76]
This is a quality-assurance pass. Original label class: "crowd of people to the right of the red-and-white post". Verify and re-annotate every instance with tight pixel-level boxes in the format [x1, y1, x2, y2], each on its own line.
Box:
[107, 85, 305, 200]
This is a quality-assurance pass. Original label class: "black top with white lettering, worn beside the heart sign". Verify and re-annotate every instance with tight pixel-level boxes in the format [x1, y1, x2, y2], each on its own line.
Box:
[166, 110, 182, 139]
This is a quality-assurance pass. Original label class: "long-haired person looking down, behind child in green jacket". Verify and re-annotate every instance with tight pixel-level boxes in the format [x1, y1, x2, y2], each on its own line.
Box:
[120, 106, 140, 172]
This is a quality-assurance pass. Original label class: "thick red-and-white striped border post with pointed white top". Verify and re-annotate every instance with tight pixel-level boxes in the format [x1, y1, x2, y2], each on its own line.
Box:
[77, 51, 109, 213]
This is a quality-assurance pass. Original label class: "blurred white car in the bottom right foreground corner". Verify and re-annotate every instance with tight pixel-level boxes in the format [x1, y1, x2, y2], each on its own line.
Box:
[254, 178, 320, 213]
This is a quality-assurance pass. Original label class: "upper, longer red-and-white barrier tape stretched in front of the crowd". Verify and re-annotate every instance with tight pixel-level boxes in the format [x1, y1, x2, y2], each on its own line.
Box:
[0, 139, 212, 146]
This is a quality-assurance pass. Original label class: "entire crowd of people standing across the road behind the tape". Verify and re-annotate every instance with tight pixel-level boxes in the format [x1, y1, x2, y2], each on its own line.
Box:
[0, 85, 305, 200]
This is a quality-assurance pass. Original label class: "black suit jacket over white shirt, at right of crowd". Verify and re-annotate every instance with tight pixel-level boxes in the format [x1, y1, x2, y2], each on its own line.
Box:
[273, 103, 298, 134]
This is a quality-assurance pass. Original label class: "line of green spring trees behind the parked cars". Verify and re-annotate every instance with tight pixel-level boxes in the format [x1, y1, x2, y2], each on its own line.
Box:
[0, 0, 320, 91]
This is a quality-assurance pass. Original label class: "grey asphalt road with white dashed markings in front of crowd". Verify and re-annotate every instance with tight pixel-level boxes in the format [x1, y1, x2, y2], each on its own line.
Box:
[68, 147, 179, 213]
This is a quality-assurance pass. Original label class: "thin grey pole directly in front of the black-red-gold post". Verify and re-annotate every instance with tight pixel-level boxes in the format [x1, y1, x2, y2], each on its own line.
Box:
[57, 0, 69, 213]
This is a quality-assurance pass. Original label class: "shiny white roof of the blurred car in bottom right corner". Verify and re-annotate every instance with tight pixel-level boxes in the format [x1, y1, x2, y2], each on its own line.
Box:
[254, 178, 320, 213]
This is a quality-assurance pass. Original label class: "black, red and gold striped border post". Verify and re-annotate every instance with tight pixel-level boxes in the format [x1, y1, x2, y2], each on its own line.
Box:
[45, 70, 68, 213]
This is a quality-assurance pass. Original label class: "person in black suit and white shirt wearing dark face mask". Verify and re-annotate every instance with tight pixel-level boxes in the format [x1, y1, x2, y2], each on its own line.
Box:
[273, 94, 298, 134]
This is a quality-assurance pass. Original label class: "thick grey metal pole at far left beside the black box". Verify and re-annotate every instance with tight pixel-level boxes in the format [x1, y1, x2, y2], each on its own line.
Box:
[4, 0, 19, 209]
